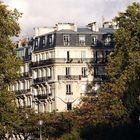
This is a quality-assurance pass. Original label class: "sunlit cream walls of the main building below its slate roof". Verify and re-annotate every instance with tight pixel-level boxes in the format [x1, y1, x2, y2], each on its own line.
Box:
[32, 47, 93, 112]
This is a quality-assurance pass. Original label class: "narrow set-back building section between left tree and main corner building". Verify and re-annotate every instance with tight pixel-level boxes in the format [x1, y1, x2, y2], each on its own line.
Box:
[13, 38, 32, 108]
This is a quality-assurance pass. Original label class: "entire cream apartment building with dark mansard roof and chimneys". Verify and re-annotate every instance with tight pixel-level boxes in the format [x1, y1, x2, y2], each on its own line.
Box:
[12, 22, 116, 112]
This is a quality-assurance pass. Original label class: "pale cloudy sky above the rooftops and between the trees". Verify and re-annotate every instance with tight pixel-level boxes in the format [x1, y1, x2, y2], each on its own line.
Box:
[3, 0, 140, 36]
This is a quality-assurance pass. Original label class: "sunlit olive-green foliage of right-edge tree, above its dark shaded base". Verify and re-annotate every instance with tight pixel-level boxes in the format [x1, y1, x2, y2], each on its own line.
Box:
[106, 3, 140, 94]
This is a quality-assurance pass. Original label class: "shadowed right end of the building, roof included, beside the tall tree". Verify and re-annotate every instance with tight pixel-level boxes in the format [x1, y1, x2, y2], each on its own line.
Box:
[91, 22, 115, 82]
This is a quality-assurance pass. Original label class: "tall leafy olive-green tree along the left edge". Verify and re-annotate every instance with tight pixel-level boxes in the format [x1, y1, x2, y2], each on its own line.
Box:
[0, 1, 21, 139]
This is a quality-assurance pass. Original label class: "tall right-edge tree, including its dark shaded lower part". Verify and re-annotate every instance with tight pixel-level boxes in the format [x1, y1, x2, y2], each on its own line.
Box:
[104, 3, 140, 123]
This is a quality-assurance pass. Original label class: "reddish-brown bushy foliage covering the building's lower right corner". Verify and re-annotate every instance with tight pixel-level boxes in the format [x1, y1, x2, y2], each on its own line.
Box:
[75, 93, 128, 128]
